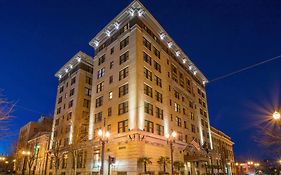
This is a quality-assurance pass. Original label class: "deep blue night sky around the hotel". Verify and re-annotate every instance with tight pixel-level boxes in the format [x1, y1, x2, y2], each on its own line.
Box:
[0, 0, 281, 159]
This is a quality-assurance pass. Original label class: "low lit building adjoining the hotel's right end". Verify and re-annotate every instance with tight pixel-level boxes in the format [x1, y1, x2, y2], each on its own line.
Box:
[211, 127, 235, 175]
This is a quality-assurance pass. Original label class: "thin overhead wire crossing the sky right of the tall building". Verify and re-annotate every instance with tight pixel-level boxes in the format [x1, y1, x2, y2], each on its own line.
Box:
[209, 55, 281, 83]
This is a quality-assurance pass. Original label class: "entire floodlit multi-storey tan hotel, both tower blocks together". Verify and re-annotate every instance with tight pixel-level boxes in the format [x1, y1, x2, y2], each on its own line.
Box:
[48, 0, 212, 175]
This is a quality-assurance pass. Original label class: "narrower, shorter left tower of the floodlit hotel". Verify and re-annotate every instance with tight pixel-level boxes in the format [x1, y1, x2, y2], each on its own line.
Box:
[48, 51, 93, 174]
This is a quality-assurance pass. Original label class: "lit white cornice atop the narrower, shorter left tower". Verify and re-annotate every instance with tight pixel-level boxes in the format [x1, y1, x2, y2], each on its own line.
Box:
[55, 51, 93, 79]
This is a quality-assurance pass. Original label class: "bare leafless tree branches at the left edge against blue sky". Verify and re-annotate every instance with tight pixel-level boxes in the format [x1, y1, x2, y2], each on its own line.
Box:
[0, 90, 14, 140]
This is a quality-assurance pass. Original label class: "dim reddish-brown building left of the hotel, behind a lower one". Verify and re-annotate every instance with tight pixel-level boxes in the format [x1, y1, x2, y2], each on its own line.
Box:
[15, 116, 53, 173]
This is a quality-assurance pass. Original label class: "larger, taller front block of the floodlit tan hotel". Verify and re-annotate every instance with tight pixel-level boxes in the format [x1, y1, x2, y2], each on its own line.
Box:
[86, 0, 212, 175]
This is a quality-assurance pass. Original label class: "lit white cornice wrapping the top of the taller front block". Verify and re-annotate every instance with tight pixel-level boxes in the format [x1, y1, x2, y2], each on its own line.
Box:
[89, 0, 208, 85]
